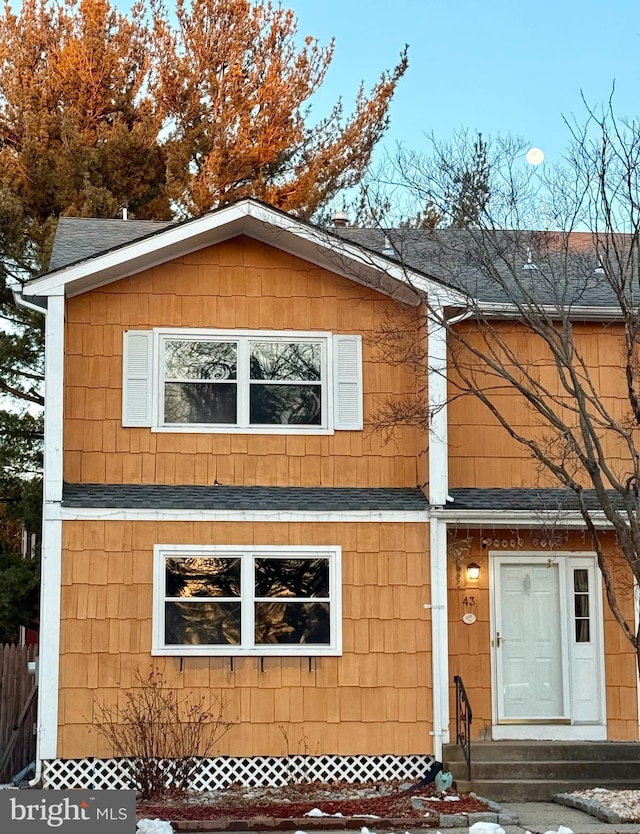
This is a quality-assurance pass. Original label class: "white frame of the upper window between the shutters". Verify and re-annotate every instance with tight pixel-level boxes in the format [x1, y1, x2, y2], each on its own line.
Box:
[151, 327, 334, 435]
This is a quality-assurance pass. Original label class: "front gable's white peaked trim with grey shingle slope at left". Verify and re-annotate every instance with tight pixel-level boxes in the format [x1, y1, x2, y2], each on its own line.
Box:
[25, 199, 463, 306]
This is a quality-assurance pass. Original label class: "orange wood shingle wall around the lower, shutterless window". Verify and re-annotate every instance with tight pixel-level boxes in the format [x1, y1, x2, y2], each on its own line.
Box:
[58, 521, 432, 758]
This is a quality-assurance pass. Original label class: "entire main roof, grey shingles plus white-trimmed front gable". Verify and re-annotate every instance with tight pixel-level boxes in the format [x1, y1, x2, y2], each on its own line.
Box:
[23, 199, 619, 319]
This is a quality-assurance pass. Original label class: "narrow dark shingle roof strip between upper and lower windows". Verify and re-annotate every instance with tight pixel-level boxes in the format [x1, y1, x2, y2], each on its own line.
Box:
[62, 483, 428, 512]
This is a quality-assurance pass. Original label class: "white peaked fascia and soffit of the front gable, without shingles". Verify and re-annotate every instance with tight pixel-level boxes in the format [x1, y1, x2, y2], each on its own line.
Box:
[29, 200, 464, 305]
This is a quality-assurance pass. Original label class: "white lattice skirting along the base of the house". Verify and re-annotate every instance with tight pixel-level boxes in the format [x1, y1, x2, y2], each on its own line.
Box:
[42, 756, 435, 791]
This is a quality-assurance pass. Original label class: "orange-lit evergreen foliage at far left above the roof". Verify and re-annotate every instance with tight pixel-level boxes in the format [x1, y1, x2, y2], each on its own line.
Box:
[0, 0, 169, 234]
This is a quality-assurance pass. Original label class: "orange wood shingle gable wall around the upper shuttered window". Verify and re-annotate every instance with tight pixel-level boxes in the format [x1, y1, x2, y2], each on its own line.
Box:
[64, 237, 426, 487]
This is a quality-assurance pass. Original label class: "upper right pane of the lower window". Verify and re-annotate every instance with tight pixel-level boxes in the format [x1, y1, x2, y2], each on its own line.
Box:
[255, 559, 329, 597]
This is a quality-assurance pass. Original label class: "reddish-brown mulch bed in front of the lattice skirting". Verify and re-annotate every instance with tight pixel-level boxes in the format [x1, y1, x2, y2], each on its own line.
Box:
[137, 783, 487, 830]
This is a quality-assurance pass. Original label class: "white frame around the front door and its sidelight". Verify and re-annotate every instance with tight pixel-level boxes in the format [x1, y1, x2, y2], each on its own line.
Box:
[488, 550, 607, 741]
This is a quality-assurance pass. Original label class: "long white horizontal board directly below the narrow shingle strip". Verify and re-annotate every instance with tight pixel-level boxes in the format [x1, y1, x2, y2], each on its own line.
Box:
[57, 507, 429, 524]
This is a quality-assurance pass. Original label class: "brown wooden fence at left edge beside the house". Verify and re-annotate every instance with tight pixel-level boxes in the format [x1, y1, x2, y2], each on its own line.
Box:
[0, 645, 37, 783]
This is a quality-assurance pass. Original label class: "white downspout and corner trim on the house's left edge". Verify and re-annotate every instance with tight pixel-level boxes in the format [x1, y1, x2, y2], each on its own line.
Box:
[12, 287, 64, 787]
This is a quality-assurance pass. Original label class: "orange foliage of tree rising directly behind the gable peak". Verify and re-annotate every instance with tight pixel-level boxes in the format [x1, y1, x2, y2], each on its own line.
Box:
[152, 0, 406, 217]
